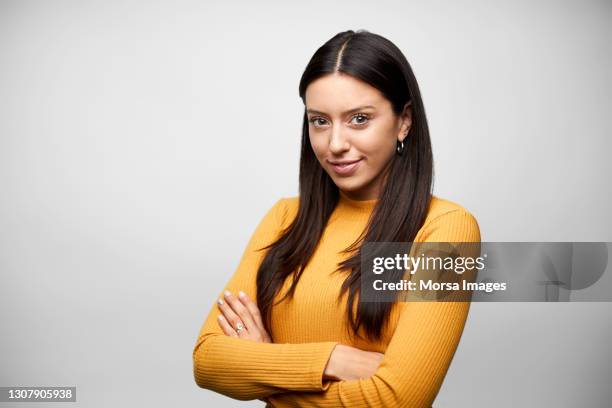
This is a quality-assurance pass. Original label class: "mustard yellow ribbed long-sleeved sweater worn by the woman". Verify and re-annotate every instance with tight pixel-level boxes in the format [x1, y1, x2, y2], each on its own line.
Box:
[193, 192, 480, 408]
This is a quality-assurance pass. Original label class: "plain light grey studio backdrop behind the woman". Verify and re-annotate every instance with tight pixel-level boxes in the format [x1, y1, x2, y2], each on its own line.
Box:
[0, 0, 612, 407]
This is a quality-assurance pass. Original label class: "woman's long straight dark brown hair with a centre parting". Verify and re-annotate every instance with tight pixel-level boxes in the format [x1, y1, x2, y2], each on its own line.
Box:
[257, 30, 433, 340]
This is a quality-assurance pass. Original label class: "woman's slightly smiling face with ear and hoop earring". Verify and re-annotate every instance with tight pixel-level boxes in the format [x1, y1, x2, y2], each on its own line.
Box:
[305, 73, 412, 200]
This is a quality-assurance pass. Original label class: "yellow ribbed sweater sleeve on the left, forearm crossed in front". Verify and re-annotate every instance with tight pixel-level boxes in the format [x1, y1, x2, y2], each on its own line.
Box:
[193, 198, 337, 400]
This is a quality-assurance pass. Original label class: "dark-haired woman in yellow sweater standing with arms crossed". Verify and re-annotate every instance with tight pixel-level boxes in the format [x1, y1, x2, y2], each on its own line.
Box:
[193, 30, 480, 407]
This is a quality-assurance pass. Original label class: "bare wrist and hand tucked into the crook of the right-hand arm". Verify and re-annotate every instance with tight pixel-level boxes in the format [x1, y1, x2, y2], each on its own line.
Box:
[323, 344, 385, 380]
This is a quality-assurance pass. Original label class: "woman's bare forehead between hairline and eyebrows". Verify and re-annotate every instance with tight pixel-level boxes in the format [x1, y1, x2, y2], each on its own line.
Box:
[305, 73, 387, 113]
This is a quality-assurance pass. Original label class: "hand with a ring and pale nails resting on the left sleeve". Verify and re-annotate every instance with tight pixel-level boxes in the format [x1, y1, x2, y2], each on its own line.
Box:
[217, 290, 272, 343]
